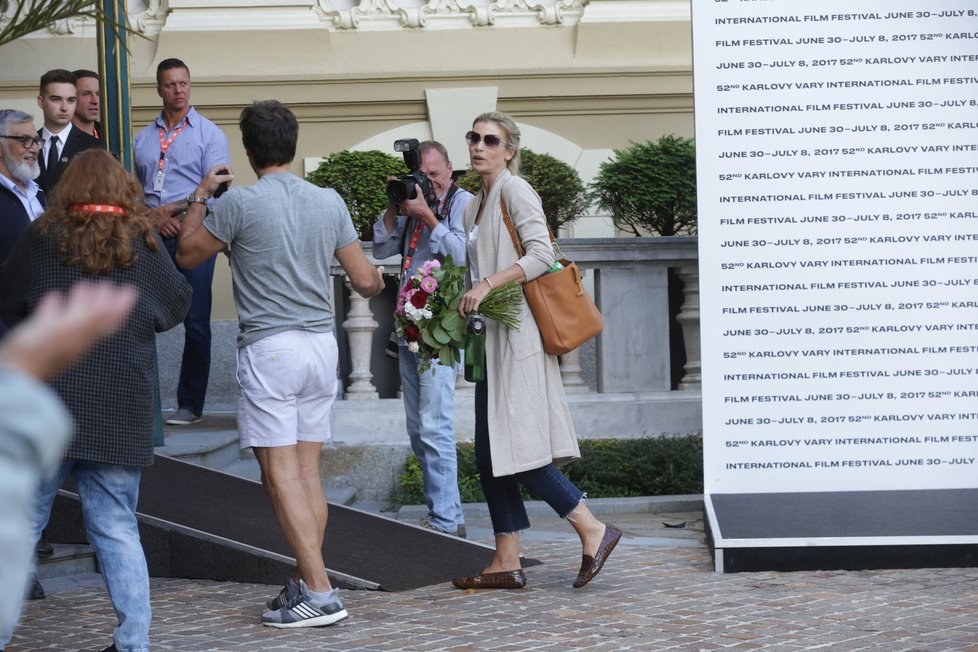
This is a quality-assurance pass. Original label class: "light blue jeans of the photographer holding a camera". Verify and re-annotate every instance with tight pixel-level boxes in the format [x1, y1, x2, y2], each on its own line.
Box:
[398, 346, 465, 532]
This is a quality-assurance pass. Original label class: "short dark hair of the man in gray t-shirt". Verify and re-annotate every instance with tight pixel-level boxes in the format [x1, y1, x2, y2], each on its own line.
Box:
[238, 100, 299, 169]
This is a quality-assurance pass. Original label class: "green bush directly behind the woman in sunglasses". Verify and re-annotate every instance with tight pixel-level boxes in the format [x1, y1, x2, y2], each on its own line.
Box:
[459, 148, 589, 235]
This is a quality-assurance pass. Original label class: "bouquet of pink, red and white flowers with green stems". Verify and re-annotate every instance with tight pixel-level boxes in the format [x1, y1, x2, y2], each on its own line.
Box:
[394, 256, 523, 370]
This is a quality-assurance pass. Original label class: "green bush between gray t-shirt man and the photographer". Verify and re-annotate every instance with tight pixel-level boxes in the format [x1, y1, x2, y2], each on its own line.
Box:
[306, 150, 408, 240]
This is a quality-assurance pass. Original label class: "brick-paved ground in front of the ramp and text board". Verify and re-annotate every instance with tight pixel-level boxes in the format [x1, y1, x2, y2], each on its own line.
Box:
[8, 514, 978, 652]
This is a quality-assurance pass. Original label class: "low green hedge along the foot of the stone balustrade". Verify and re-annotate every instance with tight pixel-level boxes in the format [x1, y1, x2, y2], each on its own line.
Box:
[390, 435, 703, 508]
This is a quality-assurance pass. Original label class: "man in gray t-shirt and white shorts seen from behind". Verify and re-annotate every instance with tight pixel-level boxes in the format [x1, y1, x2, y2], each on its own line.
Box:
[176, 100, 384, 628]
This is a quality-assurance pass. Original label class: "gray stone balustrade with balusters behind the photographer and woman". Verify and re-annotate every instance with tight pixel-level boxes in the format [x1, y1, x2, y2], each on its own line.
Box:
[158, 237, 702, 441]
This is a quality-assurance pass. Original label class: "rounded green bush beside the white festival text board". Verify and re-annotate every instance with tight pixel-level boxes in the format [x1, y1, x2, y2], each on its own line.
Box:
[590, 135, 696, 236]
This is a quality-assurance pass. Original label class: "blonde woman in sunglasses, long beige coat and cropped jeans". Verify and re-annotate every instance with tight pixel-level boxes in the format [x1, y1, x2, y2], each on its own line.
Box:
[452, 113, 621, 589]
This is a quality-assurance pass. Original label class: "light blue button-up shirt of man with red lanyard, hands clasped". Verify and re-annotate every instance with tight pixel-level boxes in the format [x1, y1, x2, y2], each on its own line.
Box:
[132, 107, 231, 208]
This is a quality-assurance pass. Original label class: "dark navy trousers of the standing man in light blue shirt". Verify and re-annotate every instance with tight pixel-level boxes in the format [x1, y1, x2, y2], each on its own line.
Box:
[163, 238, 217, 415]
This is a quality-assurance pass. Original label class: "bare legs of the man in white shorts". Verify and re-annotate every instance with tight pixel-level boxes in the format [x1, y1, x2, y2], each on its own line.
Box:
[253, 442, 333, 593]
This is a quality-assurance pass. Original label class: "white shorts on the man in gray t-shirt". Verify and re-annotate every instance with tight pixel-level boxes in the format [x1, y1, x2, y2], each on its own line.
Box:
[238, 330, 339, 448]
